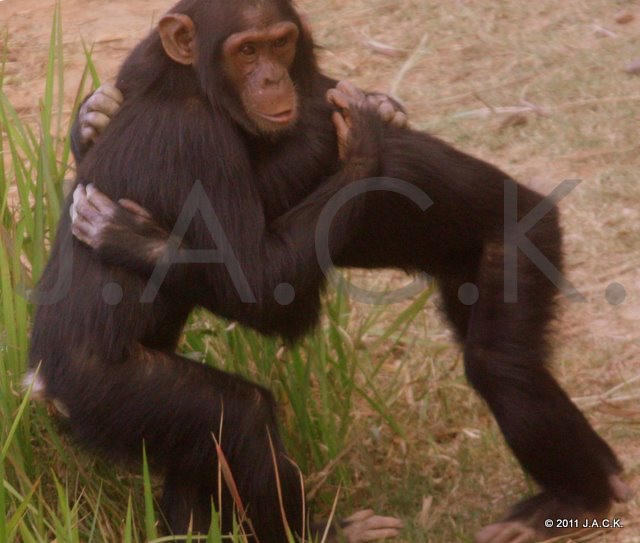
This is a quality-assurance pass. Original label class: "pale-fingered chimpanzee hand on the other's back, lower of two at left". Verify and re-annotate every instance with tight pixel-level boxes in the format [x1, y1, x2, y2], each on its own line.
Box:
[70, 185, 169, 271]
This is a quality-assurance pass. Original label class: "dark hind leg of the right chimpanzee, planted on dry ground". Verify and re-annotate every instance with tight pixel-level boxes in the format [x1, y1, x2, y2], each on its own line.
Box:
[443, 205, 621, 542]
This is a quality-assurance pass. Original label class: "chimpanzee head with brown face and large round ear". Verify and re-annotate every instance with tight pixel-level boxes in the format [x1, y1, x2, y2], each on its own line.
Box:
[158, 0, 316, 136]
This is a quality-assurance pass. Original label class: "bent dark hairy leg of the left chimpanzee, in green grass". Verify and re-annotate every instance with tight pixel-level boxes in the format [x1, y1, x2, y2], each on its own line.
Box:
[51, 347, 303, 543]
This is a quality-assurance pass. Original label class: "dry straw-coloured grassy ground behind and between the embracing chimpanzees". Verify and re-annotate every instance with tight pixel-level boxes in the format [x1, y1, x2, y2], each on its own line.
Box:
[0, 0, 640, 543]
